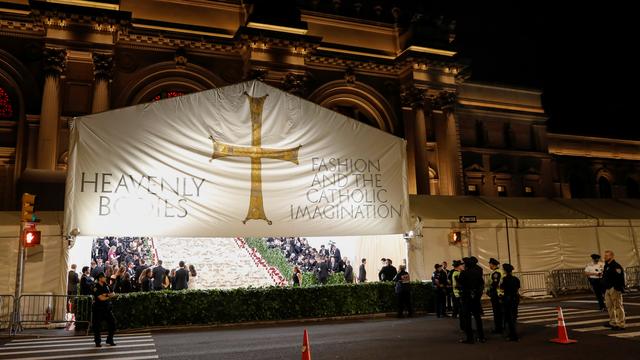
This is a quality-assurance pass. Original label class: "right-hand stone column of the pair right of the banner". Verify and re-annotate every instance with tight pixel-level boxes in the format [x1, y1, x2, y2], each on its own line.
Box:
[436, 91, 464, 195]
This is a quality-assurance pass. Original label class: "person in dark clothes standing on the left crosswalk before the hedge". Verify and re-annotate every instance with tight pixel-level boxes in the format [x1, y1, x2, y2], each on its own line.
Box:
[93, 273, 116, 347]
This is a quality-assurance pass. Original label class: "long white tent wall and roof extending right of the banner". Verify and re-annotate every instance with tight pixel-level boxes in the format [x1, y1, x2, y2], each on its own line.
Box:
[410, 196, 640, 279]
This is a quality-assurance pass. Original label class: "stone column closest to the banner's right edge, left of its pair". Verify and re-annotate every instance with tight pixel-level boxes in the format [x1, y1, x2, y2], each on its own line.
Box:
[400, 86, 431, 195]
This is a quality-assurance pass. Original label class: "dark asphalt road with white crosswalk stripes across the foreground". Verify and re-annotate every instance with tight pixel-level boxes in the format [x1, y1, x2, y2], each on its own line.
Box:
[0, 294, 640, 360]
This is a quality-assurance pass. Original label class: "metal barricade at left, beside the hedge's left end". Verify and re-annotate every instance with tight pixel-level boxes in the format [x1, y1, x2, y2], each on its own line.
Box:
[14, 294, 93, 329]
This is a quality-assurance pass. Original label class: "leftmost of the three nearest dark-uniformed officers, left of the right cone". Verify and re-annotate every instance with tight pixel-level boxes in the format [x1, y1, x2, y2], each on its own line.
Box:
[457, 256, 487, 344]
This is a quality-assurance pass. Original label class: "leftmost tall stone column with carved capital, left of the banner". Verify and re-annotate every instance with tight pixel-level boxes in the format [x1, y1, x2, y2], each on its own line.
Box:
[36, 48, 67, 170]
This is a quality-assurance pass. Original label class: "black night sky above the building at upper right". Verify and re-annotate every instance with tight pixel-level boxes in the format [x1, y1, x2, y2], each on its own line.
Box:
[457, 1, 640, 140]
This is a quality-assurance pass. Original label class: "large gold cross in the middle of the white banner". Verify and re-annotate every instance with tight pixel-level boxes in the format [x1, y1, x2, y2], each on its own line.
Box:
[209, 92, 302, 225]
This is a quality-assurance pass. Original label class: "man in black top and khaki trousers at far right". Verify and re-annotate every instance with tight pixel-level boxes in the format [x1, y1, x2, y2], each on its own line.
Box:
[602, 250, 625, 330]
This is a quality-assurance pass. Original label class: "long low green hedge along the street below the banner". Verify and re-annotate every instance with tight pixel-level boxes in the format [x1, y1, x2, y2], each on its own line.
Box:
[113, 282, 433, 329]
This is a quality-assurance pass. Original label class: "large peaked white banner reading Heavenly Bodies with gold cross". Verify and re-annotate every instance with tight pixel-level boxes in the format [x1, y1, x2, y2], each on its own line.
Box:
[65, 81, 409, 237]
